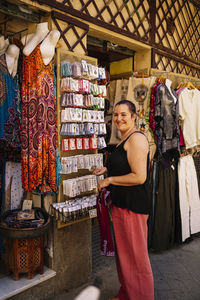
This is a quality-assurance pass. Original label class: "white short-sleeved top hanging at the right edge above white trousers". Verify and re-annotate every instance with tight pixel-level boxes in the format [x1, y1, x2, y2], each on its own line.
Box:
[178, 88, 200, 149]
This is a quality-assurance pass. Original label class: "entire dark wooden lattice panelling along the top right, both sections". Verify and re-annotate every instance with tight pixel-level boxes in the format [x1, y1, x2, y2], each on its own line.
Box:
[35, 0, 200, 64]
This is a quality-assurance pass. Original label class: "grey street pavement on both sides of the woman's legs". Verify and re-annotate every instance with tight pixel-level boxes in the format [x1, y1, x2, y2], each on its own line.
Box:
[52, 227, 200, 300]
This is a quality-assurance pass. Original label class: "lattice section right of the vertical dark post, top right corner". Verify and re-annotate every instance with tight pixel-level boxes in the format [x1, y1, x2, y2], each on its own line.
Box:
[155, 0, 200, 61]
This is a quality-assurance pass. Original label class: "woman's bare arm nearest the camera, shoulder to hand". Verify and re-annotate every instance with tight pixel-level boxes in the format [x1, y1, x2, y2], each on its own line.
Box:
[98, 133, 149, 189]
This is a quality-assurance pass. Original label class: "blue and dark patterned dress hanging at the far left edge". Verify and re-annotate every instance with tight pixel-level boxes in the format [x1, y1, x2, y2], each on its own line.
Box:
[0, 54, 21, 155]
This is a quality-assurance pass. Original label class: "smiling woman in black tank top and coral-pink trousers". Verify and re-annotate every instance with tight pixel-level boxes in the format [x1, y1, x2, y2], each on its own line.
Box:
[94, 100, 154, 300]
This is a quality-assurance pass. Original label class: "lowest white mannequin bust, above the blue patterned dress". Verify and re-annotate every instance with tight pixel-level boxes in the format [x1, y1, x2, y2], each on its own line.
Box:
[6, 44, 19, 77]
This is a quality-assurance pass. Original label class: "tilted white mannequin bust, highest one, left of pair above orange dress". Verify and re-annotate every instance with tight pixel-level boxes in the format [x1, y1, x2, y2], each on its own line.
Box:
[23, 22, 49, 56]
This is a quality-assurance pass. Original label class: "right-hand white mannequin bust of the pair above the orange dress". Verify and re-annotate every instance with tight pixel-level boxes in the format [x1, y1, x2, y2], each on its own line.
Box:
[40, 30, 60, 66]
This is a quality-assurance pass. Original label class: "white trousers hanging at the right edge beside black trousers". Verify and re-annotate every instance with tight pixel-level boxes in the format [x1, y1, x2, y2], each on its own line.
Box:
[178, 155, 200, 242]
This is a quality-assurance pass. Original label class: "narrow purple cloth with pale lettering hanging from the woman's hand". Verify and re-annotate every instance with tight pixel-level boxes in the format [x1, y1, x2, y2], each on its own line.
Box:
[96, 188, 115, 256]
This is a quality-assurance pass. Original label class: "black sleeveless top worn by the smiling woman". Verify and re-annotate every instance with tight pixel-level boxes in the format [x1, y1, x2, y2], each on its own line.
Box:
[107, 131, 151, 214]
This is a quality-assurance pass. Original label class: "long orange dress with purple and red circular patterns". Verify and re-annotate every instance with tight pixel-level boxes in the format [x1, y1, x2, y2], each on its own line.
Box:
[21, 45, 57, 192]
